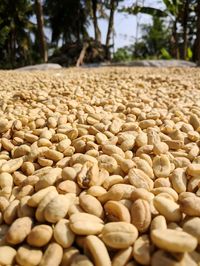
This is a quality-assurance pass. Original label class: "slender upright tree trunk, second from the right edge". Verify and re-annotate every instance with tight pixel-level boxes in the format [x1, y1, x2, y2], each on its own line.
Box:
[182, 0, 189, 60]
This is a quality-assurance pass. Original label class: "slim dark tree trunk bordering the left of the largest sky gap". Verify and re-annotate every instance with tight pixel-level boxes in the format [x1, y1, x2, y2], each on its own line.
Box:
[106, 0, 115, 59]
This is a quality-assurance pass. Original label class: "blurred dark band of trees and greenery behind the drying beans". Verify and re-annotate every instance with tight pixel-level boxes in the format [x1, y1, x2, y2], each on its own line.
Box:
[0, 0, 200, 69]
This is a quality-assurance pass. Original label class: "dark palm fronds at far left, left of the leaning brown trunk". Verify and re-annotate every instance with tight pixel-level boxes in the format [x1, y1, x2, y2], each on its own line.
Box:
[0, 0, 35, 67]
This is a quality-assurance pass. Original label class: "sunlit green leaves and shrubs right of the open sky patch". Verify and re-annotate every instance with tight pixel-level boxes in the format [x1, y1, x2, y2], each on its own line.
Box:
[120, 0, 198, 60]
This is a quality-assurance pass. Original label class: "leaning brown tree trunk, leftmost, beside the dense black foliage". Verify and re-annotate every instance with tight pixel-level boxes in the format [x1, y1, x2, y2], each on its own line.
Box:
[35, 0, 48, 62]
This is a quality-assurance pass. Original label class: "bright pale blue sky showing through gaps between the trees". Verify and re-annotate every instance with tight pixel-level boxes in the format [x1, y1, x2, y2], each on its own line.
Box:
[88, 0, 164, 51]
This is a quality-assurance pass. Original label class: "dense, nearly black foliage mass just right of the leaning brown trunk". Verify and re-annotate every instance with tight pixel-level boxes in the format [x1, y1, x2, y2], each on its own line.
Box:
[44, 0, 89, 44]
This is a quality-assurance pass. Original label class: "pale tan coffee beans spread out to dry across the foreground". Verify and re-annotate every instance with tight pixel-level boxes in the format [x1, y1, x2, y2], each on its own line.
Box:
[0, 68, 200, 266]
